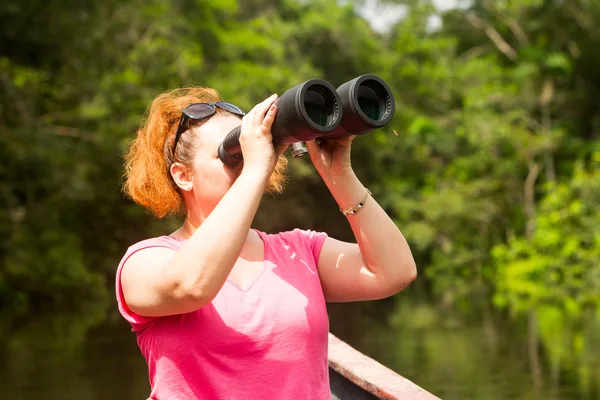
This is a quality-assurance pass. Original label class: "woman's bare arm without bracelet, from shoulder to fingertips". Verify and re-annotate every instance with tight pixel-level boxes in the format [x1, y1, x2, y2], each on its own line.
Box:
[121, 97, 284, 316]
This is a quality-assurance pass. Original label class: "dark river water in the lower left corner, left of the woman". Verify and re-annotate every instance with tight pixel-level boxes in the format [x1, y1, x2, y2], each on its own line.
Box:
[0, 308, 149, 400]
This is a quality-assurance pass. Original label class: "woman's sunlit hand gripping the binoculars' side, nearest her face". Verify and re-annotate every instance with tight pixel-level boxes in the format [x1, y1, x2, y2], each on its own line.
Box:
[240, 94, 289, 176]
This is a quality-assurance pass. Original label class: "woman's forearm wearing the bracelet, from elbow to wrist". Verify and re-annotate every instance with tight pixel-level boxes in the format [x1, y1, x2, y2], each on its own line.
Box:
[325, 170, 416, 284]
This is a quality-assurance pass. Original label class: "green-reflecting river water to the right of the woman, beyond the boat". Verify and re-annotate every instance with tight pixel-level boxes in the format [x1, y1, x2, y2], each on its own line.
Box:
[354, 296, 600, 400]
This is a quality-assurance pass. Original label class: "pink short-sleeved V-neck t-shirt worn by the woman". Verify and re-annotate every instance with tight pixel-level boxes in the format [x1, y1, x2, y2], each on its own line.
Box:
[116, 229, 331, 400]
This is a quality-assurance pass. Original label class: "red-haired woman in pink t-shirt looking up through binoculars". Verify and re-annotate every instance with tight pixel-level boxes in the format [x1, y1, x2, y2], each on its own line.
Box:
[116, 88, 416, 399]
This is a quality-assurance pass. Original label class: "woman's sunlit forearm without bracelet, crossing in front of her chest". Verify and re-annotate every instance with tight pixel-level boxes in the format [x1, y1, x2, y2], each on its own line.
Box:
[169, 167, 268, 301]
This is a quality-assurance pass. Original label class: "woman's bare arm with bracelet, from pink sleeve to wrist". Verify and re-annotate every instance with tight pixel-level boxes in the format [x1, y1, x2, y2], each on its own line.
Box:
[319, 172, 417, 302]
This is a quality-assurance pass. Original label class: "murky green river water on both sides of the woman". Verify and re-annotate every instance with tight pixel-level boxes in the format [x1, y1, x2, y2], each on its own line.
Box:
[0, 293, 600, 400]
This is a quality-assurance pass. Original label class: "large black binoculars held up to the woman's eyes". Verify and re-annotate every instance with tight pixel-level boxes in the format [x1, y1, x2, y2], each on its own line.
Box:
[218, 74, 395, 167]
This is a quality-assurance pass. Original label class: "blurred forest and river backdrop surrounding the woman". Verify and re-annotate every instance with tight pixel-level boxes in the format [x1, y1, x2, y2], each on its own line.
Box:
[0, 0, 600, 400]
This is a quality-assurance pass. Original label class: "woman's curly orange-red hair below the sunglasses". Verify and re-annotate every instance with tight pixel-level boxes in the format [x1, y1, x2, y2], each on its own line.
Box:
[123, 87, 287, 218]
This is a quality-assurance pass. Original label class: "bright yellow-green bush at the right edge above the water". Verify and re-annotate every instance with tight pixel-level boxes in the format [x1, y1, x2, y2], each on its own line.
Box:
[492, 153, 600, 316]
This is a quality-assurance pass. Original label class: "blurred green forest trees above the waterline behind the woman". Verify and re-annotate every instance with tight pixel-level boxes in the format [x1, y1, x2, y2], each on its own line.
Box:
[0, 0, 600, 364]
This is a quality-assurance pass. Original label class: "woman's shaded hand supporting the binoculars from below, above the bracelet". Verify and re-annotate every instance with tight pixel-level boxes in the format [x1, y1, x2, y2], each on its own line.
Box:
[306, 136, 355, 184]
